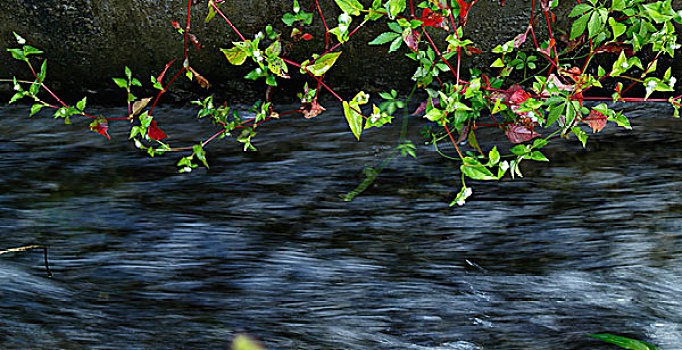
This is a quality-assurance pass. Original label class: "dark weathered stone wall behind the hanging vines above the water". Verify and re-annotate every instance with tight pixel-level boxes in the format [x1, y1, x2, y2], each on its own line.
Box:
[0, 0, 682, 101]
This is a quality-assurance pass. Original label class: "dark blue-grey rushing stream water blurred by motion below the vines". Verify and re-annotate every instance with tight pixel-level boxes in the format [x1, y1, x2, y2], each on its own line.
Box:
[0, 105, 682, 350]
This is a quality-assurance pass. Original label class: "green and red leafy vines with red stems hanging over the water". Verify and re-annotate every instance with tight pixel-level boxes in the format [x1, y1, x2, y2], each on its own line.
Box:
[8, 0, 682, 205]
